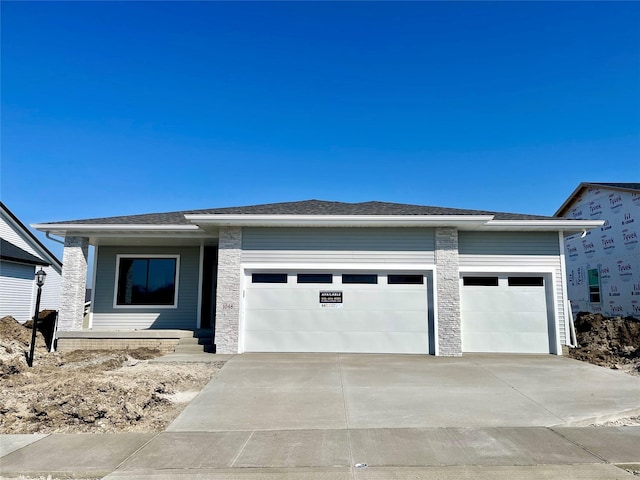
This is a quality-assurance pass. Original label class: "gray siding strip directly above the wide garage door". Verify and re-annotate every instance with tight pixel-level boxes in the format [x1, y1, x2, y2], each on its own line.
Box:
[242, 228, 435, 264]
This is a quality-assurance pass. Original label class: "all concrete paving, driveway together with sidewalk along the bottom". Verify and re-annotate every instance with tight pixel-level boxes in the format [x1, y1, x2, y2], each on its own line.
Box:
[0, 354, 640, 480]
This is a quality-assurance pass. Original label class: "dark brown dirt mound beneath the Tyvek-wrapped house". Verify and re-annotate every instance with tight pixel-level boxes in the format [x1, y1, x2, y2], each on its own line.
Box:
[569, 312, 640, 375]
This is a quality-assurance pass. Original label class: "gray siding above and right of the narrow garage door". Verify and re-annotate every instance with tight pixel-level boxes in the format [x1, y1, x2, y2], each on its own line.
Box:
[459, 232, 566, 344]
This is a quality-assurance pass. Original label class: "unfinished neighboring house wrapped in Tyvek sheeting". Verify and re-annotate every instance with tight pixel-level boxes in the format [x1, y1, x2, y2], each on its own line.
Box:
[555, 182, 640, 318]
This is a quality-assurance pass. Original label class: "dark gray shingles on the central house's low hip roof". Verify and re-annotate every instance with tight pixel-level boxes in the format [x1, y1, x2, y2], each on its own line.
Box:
[49, 200, 555, 225]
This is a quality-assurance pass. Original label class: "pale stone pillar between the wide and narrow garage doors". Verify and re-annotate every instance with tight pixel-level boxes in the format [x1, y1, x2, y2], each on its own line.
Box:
[435, 227, 462, 357]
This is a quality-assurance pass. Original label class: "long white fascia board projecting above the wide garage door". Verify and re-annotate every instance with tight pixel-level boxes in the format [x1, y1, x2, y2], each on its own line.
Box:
[185, 214, 493, 227]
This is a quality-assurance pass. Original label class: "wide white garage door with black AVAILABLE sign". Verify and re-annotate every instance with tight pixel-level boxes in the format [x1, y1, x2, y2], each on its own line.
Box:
[244, 272, 429, 354]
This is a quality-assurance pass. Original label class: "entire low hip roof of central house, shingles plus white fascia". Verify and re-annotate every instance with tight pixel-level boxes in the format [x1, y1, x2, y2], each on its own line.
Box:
[34, 200, 599, 235]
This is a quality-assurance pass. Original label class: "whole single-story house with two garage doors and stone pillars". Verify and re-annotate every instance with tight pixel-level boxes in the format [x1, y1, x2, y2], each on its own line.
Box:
[34, 200, 602, 356]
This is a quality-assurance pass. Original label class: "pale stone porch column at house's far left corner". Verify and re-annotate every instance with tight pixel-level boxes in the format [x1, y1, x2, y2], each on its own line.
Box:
[58, 237, 89, 331]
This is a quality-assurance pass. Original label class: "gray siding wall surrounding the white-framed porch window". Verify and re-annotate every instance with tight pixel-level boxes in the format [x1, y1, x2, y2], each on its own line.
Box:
[93, 247, 200, 329]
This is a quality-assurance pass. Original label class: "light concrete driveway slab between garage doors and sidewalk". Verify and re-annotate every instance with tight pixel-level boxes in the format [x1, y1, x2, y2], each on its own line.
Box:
[167, 354, 640, 432]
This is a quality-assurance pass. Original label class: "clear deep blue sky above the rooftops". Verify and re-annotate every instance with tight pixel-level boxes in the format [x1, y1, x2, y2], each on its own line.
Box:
[0, 1, 640, 262]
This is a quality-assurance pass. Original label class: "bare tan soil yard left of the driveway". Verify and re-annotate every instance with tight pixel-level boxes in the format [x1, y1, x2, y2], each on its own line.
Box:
[0, 317, 224, 433]
